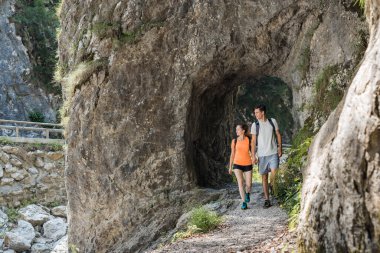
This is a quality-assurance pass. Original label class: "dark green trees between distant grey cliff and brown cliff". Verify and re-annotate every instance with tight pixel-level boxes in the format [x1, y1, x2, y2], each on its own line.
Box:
[13, 0, 62, 95]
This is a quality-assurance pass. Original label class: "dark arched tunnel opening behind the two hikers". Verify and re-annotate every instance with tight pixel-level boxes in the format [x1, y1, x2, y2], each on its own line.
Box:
[185, 76, 294, 188]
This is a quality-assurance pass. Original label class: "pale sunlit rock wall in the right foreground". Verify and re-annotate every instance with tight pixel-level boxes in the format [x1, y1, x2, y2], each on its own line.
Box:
[299, 0, 380, 252]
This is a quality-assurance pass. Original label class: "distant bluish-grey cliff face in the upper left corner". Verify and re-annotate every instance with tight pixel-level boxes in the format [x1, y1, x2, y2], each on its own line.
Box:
[0, 0, 59, 122]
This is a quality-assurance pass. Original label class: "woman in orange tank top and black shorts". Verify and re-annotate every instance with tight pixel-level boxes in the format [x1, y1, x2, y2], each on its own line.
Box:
[228, 124, 252, 210]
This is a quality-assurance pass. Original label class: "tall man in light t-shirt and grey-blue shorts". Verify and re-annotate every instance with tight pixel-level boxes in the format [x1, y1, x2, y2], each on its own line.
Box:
[251, 105, 282, 208]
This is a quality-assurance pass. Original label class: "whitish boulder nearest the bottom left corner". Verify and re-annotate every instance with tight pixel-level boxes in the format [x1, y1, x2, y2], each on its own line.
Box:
[4, 220, 35, 252]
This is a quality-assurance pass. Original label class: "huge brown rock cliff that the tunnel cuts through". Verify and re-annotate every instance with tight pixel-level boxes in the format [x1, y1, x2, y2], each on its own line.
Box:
[59, 0, 361, 252]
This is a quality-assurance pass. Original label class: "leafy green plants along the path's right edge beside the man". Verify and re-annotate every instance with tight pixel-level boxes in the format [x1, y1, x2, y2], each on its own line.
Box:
[274, 137, 312, 229]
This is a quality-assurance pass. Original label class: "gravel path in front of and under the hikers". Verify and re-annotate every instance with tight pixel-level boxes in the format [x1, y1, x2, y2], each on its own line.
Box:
[153, 183, 295, 253]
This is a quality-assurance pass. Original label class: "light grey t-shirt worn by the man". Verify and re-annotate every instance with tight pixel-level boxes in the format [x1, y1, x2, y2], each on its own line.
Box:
[251, 119, 278, 157]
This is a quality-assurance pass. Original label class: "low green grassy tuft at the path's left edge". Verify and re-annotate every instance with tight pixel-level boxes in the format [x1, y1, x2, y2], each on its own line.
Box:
[172, 207, 223, 241]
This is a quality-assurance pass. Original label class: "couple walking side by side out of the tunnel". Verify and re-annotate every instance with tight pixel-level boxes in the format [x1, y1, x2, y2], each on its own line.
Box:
[229, 105, 282, 209]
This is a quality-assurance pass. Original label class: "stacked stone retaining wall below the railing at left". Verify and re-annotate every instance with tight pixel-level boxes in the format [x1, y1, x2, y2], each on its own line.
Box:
[0, 146, 67, 207]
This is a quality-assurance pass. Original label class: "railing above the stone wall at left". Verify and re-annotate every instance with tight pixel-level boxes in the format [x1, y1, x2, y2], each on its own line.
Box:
[0, 119, 64, 144]
